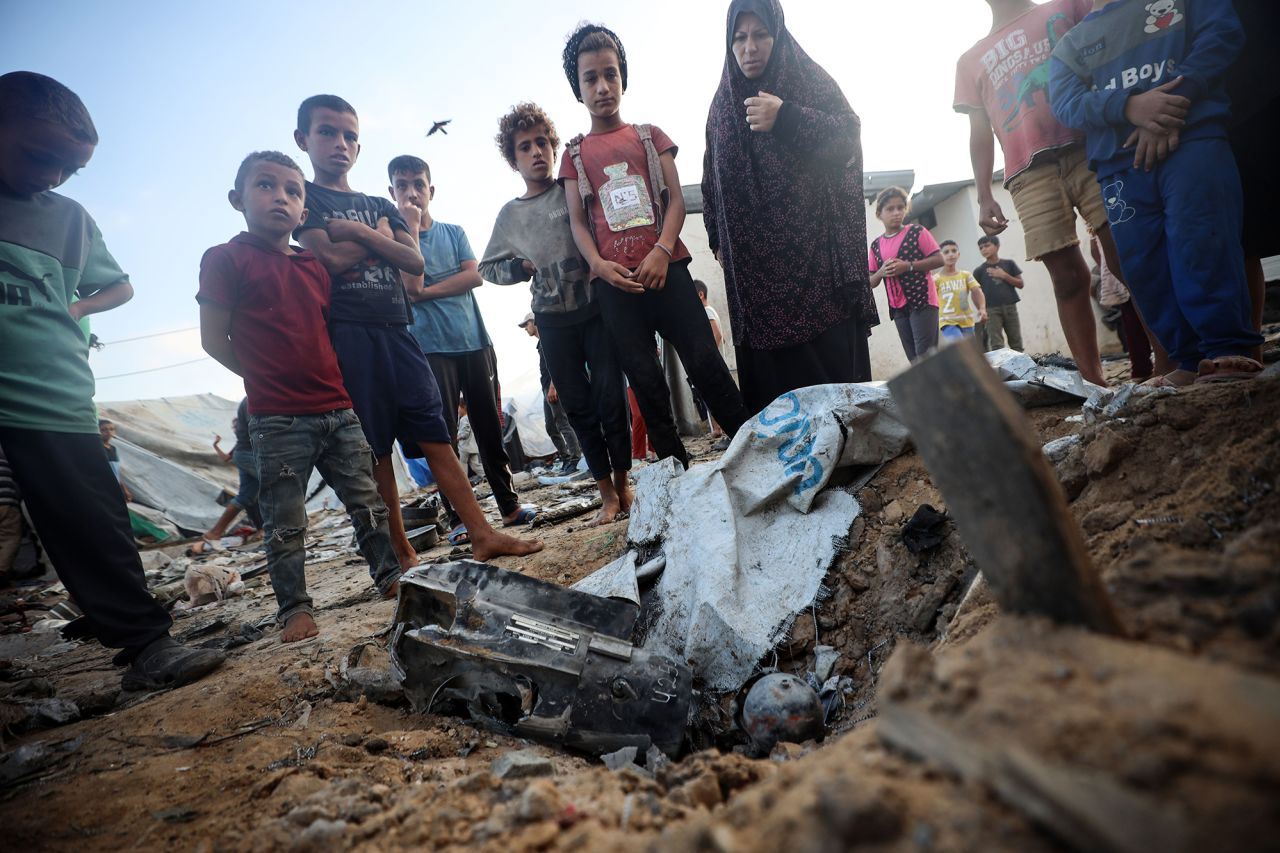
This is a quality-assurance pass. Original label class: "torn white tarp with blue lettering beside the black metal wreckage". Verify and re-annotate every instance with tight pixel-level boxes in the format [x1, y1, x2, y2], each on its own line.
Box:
[575, 383, 908, 690]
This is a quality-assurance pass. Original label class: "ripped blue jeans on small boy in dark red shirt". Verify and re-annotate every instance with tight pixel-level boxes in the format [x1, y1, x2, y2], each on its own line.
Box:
[250, 409, 401, 624]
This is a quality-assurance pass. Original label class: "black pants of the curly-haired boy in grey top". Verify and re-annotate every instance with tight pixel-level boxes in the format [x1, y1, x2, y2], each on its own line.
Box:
[538, 308, 631, 480]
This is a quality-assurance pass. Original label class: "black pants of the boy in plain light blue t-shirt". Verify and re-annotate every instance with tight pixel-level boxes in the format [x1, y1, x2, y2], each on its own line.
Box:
[426, 347, 520, 517]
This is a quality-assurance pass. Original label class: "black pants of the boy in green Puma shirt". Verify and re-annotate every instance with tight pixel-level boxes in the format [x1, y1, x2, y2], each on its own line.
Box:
[0, 427, 173, 662]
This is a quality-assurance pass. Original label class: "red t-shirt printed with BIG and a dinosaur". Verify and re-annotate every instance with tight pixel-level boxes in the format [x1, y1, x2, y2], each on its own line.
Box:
[955, 0, 1093, 183]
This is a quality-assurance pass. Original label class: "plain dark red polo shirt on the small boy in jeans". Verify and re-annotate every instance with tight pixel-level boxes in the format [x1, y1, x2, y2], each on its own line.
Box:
[196, 233, 351, 415]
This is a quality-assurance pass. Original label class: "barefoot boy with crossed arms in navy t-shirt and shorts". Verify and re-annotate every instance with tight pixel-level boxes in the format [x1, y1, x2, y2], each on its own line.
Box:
[293, 95, 541, 569]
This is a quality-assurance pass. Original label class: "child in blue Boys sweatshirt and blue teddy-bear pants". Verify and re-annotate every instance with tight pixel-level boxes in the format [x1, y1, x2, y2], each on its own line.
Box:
[1050, 0, 1262, 386]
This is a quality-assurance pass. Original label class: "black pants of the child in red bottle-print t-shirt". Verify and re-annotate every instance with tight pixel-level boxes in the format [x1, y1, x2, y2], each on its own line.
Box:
[594, 261, 748, 466]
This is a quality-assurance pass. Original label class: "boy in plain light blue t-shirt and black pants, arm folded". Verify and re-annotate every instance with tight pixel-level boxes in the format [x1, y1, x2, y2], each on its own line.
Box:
[387, 154, 538, 543]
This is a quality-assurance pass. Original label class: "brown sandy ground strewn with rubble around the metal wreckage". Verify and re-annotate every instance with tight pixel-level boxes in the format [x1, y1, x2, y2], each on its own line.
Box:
[0, 350, 1280, 853]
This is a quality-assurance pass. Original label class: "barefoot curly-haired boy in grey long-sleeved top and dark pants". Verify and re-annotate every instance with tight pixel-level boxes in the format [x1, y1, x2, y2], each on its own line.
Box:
[480, 104, 631, 524]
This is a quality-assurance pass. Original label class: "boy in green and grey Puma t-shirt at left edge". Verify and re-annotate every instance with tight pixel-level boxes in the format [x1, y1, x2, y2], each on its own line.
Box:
[0, 72, 225, 690]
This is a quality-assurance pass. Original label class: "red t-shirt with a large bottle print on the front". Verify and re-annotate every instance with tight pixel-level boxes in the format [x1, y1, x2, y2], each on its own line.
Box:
[559, 124, 690, 269]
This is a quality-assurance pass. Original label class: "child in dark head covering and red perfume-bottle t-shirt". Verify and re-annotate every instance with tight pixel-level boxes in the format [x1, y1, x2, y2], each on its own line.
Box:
[559, 24, 748, 466]
